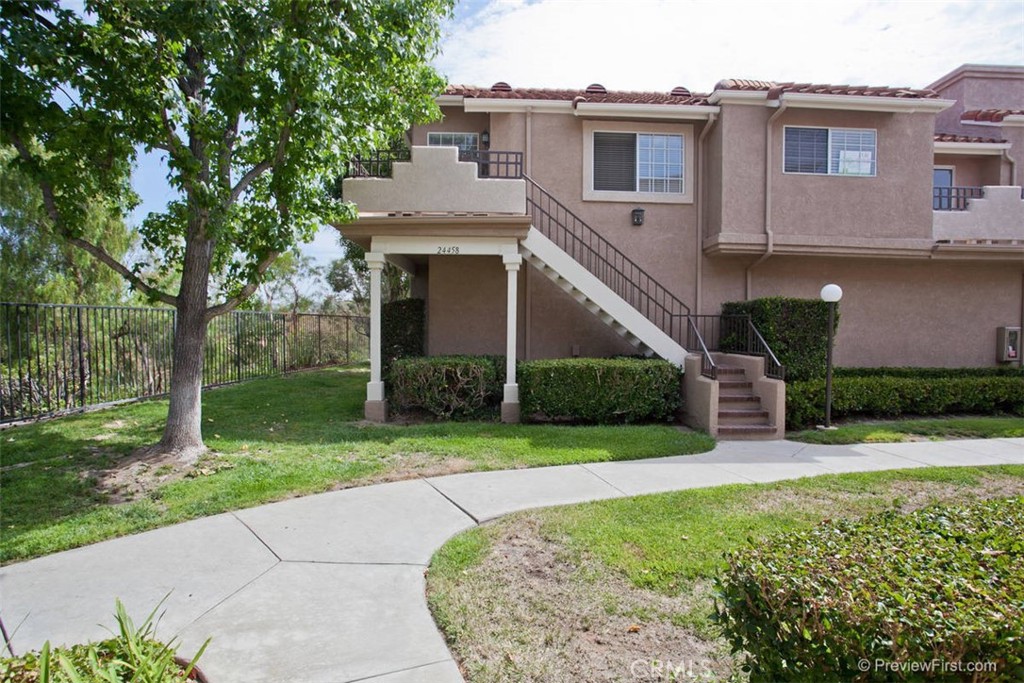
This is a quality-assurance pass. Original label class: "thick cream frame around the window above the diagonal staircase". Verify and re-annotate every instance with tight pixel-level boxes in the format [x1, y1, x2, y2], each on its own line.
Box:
[583, 121, 695, 204]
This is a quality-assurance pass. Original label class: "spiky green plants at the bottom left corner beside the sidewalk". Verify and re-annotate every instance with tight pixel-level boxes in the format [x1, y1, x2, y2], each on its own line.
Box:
[0, 598, 210, 683]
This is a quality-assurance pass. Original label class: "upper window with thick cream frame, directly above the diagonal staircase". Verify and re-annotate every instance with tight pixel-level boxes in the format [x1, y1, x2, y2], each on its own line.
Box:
[584, 122, 692, 203]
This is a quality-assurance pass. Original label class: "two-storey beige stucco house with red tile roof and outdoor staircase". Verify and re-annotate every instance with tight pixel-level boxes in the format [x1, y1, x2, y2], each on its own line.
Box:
[341, 65, 1024, 433]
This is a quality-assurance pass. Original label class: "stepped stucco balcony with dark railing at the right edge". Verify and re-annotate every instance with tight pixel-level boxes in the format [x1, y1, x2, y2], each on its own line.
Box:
[932, 185, 1024, 249]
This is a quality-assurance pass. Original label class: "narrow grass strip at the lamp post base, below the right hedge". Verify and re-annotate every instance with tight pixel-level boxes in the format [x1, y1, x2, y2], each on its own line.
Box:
[786, 417, 1024, 444]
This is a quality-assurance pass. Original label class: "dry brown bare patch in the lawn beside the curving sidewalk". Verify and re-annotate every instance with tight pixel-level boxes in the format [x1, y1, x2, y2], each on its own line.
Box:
[429, 514, 735, 683]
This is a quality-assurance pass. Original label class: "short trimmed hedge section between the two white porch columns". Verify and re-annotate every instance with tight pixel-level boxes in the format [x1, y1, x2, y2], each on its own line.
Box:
[388, 355, 505, 419]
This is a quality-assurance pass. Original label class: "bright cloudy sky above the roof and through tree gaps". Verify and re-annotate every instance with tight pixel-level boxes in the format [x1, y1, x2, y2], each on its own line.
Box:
[128, 0, 1024, 296]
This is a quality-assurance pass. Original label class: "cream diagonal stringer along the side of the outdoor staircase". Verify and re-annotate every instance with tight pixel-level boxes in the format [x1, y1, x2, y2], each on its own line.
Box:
[519, 227, 687, 368]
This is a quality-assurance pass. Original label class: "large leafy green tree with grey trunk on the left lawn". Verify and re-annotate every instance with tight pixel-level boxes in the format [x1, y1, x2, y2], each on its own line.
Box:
[0, 0, 452, 460]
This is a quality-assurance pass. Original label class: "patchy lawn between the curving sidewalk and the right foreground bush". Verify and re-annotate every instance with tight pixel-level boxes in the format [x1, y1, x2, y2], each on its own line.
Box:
[427, 465, 1024, 681]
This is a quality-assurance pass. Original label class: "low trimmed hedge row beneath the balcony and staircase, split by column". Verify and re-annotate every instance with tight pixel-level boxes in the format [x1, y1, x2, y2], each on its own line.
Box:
[388, 355, 682, 424]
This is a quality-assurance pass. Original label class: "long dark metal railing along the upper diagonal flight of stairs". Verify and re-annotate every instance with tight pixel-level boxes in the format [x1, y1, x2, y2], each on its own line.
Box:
[522, 175, 690, 347]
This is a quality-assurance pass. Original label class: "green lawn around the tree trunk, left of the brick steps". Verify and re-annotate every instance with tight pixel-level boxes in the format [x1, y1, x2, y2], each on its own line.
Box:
[0, 370, 714, 562]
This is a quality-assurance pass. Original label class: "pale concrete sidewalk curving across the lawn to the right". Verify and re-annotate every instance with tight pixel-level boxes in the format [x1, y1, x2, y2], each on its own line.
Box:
[6, 438, 1024, 683]
